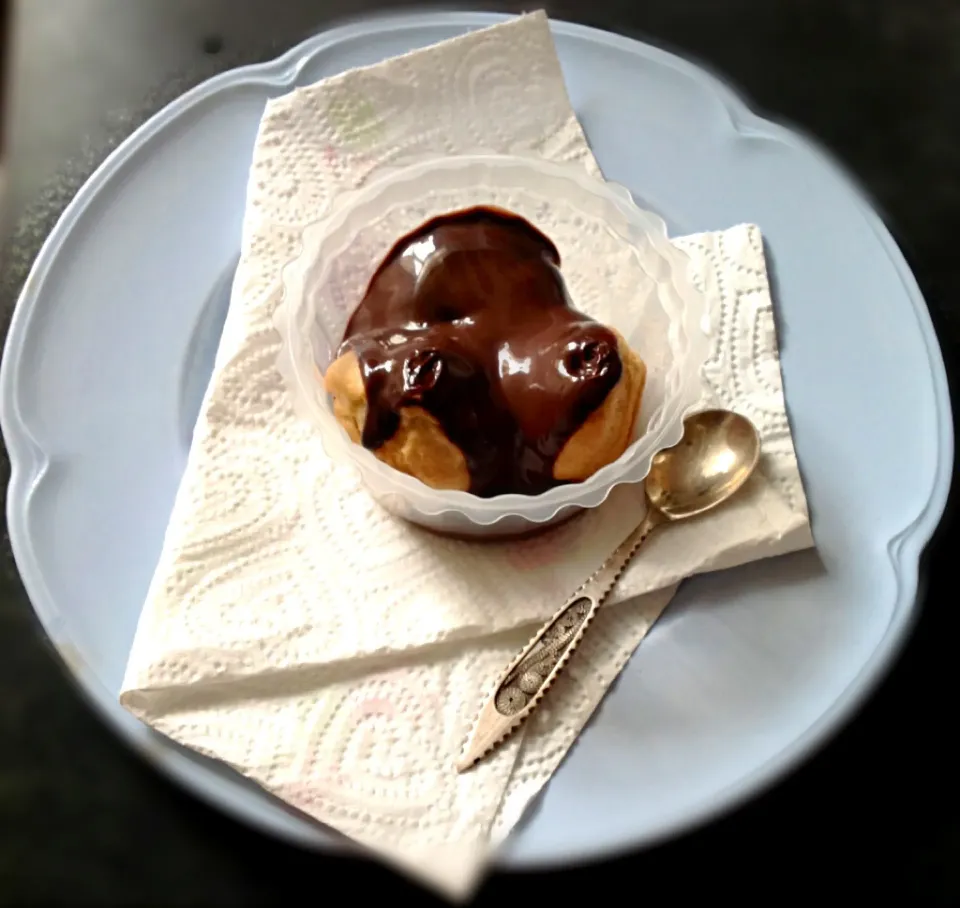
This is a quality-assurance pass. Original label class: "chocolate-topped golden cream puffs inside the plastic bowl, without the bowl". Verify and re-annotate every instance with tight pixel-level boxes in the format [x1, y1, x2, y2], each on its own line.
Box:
[324, 207, 646, 498]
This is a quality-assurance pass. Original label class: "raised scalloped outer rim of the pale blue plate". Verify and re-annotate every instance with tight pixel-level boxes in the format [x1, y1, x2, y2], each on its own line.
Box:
[0, 11, 954, 868]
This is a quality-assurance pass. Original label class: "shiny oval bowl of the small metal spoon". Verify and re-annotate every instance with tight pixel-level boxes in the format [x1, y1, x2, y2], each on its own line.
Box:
[645, 410, 760, 520]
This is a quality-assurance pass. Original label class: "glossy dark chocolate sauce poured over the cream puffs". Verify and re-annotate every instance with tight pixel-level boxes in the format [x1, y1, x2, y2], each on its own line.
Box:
[341, 208, 623, 498]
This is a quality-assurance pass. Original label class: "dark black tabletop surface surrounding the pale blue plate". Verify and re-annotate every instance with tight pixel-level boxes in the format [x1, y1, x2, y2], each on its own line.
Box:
[0, 0, 960, 906]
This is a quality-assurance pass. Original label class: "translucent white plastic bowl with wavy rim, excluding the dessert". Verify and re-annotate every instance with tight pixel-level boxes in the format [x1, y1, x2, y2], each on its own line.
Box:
[274, 155, 708, 536]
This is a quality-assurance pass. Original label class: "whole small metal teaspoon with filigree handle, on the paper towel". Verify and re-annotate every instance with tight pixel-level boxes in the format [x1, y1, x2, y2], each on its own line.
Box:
[457, 410, 760, 772]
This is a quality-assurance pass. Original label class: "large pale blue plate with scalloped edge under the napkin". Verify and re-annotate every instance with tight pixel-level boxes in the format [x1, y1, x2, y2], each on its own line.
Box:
[0, 13, 953, 866]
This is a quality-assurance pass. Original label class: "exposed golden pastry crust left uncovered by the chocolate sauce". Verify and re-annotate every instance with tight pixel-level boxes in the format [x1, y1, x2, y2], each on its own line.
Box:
[324, 334, 647, 491]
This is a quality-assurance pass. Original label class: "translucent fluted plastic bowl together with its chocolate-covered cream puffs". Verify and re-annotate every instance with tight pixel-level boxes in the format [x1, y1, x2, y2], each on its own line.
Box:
[275, 155, 707, 536]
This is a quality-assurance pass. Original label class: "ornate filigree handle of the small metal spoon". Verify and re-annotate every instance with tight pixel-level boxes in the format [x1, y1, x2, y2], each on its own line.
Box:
[457, 507, 665, 772]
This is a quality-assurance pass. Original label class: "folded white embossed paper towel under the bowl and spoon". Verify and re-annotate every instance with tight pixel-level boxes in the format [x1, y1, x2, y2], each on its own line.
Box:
[121, 14, 812, 898]
